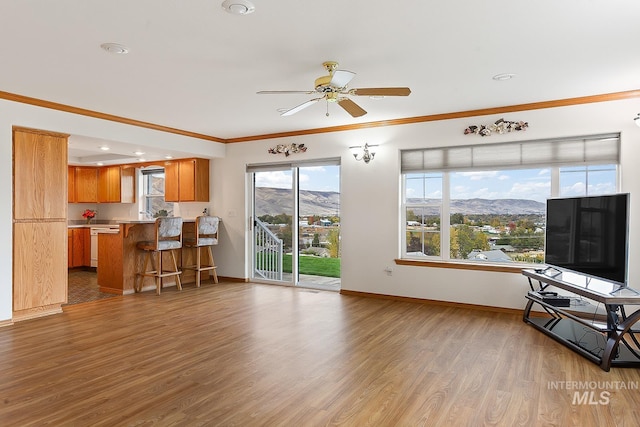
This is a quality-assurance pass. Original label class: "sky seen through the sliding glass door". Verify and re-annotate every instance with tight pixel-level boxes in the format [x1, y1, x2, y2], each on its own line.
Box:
[256, 165, 340, 193]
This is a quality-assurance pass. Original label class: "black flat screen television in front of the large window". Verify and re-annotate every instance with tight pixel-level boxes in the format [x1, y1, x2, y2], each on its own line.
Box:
[544, 193, 629, 286]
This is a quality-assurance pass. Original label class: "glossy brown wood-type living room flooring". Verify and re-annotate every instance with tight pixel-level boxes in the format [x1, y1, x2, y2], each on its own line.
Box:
[0, 282, 640, 427]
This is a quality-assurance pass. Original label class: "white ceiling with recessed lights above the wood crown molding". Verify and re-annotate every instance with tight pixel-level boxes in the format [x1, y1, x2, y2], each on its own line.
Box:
[0, 0, 640, 164]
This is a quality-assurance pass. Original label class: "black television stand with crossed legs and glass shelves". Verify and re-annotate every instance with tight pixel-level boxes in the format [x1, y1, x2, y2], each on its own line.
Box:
[522, 269, 640, 371]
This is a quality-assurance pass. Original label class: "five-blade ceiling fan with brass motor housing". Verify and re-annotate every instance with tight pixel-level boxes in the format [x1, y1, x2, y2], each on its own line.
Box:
[258, 61, 411, 117]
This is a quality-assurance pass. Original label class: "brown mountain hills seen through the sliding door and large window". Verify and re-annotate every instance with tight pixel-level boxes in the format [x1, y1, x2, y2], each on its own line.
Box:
[256, 187, 546, 216]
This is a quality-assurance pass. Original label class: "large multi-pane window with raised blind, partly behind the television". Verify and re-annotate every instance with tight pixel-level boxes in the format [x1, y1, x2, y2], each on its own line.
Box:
[402, 135, 619, 263]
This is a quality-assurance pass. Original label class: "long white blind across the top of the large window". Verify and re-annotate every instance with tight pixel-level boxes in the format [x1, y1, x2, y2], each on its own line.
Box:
[401, 134, 620, 173]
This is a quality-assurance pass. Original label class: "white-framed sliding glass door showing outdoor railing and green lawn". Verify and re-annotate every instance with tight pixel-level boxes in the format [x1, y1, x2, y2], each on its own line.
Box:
[248, 162, 340, 290]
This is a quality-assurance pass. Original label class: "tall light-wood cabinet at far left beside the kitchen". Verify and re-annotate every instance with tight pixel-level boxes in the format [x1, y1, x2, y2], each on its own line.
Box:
[13, 127, 68, 320]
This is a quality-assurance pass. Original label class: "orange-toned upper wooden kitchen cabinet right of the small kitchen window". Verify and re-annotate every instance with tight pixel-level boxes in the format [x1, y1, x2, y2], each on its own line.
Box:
[164, 158, 209, 202]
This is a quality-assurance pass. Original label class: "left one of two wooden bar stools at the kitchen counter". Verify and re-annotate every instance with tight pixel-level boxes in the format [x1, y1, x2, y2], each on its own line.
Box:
[135, 217, 182, 295]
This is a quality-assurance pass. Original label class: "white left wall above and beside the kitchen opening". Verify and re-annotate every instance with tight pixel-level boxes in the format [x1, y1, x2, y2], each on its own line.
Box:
[0, 100, 225, 322]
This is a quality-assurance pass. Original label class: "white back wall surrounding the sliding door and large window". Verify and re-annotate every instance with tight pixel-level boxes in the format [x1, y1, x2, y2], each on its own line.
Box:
[213, 99, 640, 309]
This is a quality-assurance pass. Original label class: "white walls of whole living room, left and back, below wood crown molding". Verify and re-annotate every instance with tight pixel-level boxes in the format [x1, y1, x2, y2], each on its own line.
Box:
[0, 95, 640, 321]
